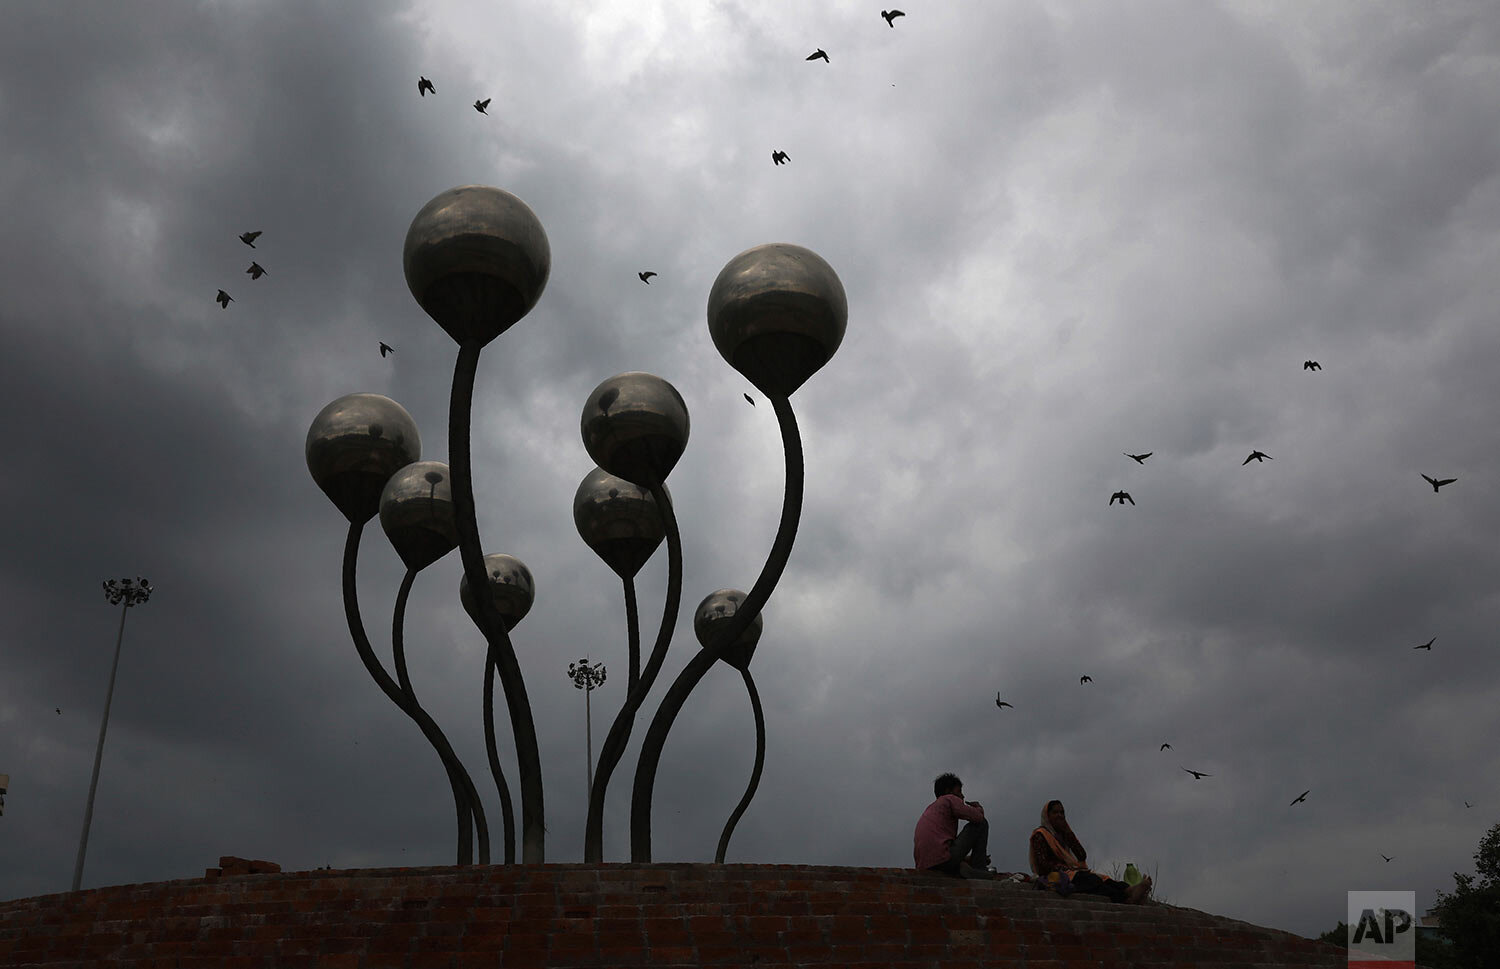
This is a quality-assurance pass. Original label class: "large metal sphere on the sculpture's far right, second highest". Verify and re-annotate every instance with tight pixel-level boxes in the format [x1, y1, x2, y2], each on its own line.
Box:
[708, 243, 849, 398]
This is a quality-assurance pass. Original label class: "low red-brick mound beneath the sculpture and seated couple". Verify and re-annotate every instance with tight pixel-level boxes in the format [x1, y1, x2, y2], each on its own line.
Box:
[0, 858, 1346, 969]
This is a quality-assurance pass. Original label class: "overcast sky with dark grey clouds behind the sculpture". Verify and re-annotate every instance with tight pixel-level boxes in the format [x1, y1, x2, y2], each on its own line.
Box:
[0, 0, 1500, 935]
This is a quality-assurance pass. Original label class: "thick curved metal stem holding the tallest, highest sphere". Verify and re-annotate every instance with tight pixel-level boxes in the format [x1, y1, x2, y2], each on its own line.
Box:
[449, 341, 546, 864]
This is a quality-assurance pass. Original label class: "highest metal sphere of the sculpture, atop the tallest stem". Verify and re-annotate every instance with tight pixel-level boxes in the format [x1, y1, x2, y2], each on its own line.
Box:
[401, 185, 552, 347]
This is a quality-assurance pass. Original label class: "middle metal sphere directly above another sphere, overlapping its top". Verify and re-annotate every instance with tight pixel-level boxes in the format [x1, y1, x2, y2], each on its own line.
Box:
[582, 372, 687, 488]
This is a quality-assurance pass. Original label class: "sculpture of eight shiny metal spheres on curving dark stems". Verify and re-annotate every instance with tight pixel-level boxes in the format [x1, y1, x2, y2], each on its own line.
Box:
[303, 185, 849, 864]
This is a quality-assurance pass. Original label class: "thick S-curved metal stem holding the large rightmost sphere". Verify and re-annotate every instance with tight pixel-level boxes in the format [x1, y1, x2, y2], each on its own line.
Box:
[630, 396, 803, 864]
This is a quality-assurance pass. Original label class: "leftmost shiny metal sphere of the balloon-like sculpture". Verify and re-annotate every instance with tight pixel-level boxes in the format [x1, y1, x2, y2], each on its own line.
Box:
[306, 393, 422, 525]
